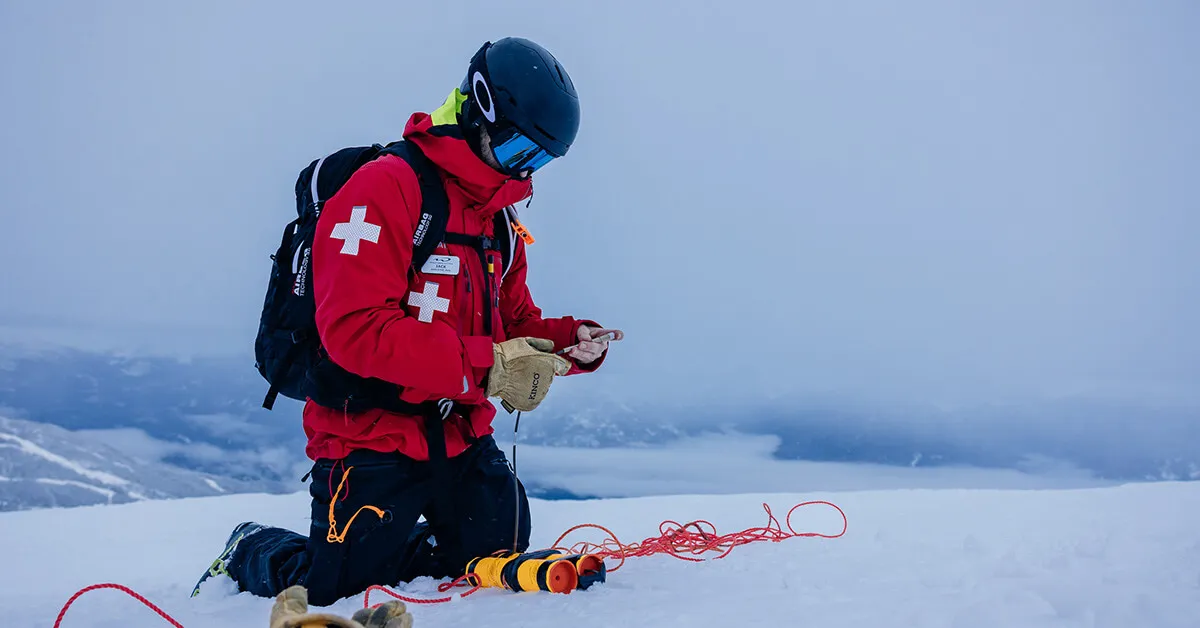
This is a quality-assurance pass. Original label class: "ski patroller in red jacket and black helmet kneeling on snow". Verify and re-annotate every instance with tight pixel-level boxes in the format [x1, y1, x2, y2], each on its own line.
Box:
[197, 38, 623, 606]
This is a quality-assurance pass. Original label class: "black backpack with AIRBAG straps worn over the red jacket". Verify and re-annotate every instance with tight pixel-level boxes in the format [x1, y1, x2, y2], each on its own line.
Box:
[254, 140, 516, 413]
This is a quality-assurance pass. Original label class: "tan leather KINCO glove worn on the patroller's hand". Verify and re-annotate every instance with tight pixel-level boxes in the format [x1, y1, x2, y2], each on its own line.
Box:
[487, 337, 571, 412]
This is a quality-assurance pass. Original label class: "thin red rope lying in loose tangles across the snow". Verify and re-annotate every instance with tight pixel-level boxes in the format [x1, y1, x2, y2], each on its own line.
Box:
[54, 500, 850, 628]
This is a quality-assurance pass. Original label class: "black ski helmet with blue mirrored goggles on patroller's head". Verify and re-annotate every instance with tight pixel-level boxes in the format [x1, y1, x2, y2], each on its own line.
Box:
[458, 37, 580, 175]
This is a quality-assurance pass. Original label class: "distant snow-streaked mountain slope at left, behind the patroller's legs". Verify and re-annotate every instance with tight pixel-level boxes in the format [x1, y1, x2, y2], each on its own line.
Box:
[0, 417, 276, 510]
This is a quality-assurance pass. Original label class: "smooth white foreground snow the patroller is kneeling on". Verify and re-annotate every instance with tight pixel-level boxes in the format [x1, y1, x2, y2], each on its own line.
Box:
[0, 483, 1200, 628]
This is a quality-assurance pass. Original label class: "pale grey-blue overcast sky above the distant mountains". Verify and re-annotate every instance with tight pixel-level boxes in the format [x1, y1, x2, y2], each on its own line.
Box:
[0, 0, 1200, 410]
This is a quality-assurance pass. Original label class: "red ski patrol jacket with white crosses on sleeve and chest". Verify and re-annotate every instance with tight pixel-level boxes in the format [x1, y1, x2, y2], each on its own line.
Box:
[304, 101, 602, 460]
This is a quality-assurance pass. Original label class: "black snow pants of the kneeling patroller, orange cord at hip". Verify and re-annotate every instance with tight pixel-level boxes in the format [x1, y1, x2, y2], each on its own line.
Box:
[227, 436, 529, 606]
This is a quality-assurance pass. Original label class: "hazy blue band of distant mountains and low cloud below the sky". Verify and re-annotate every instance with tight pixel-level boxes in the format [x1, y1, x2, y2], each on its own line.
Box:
[0, 341, 1200, 508]
